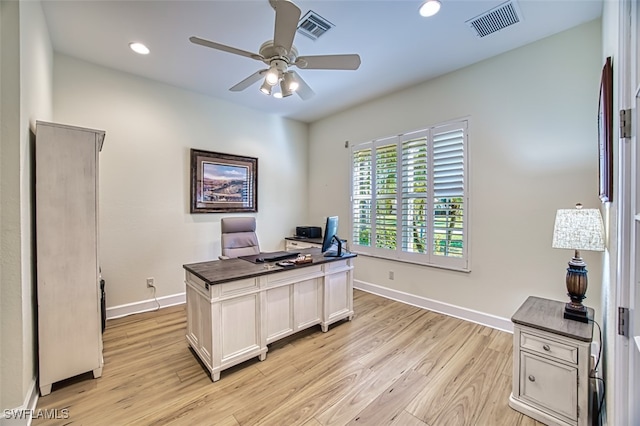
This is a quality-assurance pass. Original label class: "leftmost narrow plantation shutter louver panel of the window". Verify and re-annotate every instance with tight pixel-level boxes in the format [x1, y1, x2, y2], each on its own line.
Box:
[352, 146, 373, 246]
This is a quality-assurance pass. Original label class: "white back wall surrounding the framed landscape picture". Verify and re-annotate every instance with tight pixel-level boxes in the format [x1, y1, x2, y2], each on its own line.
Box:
[54, 54, 308, 307]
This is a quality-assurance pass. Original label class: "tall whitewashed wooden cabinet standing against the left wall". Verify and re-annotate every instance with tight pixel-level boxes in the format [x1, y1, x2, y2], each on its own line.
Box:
[35, 121, 105, 396]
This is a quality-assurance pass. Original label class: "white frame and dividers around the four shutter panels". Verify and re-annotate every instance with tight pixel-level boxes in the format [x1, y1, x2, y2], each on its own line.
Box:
[349, 118, 470, 272]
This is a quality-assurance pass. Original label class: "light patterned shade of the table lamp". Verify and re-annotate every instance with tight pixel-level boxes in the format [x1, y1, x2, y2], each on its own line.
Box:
[551, 204, 604, 251]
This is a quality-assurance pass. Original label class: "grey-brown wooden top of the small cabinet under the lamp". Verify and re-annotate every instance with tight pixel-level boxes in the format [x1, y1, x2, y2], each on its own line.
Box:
[511, 296, 593, 342]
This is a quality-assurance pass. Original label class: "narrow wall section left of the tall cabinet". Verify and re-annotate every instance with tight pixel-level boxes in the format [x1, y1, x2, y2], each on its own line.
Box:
[0, 1, 53, 409]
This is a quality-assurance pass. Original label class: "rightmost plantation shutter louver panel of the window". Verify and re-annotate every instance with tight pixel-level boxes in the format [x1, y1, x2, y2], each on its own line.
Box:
[432, 124, 466, 257]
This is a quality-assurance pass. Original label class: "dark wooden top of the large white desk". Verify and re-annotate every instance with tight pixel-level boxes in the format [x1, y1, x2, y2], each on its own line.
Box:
[182, 248, 356, 285]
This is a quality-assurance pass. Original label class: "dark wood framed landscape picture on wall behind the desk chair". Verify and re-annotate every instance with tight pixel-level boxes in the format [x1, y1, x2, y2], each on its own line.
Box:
[191, 149, 258, 213]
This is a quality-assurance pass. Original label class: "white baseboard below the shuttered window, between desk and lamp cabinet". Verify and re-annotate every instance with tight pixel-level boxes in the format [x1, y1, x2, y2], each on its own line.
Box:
[353, 280, 513, 333]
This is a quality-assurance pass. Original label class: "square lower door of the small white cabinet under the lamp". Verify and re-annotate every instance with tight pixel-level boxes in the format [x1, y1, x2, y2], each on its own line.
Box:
[520, 352, 578, 422]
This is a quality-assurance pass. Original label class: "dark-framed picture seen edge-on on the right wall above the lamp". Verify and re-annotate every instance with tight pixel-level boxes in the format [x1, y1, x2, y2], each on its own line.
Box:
[598, 57, 613, 203]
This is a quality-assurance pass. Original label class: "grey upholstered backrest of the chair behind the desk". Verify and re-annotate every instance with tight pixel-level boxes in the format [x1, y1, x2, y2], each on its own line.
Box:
[220, 217, 260, 258]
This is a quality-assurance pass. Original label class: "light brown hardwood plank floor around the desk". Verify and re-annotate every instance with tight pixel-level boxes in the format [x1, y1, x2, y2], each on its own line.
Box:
[32, 290, 540, 426]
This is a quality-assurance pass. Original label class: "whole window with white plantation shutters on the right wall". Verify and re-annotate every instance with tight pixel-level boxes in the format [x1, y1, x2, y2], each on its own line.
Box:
[351, 121, 469, 270]
